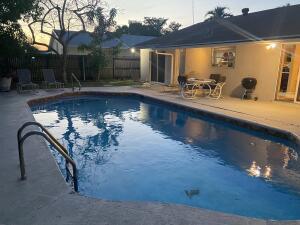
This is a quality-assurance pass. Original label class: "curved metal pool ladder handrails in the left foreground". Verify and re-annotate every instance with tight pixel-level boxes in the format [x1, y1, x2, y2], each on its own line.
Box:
[17, 122, 78, 192]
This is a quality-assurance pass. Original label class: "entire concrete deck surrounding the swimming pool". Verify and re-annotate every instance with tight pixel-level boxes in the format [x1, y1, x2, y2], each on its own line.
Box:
[0, 87, 300, 225]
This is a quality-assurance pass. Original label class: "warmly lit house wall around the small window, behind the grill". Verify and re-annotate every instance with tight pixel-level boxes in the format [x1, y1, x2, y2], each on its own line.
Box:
[185, 44, 281, 100]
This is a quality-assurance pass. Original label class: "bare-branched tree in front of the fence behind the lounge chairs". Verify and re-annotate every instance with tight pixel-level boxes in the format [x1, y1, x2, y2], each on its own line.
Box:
[28, 0, 100, 82]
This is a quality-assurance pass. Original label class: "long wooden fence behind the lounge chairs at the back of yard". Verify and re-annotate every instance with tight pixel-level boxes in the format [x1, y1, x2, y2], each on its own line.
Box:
[0, 55, 140, 82]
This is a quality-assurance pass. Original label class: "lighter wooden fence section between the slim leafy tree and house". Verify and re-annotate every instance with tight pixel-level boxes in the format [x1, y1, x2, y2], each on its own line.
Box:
[113, 57, 140, 80]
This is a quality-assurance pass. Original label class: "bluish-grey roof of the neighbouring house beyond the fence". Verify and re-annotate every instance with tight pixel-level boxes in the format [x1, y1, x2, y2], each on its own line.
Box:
[55, 30, 155, 49]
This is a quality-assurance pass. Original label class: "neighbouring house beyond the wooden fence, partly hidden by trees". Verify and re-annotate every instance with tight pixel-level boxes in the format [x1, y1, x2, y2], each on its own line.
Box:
[49, 30, 154, 57]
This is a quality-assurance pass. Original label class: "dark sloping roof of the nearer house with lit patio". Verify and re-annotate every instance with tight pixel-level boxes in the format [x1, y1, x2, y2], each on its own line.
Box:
[136, 5, 300, 48]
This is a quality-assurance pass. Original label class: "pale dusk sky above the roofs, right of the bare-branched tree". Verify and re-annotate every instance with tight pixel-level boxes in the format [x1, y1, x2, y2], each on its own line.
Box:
[106, 0, 300, 26]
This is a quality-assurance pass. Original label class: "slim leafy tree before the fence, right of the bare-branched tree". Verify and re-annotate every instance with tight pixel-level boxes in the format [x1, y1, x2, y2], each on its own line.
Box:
[79, 7, 117, 80]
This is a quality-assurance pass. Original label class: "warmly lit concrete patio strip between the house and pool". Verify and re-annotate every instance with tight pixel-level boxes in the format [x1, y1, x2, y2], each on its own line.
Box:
[138, 86, 300, 137]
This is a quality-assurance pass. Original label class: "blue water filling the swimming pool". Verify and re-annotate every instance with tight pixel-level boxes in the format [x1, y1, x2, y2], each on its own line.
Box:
[32, 96, 300, 219]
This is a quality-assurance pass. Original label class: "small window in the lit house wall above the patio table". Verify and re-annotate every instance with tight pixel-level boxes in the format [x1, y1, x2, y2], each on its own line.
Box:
[212, 47, 235, 68]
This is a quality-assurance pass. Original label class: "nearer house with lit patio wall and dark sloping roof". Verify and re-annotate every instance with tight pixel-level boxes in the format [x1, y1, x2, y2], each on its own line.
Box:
[136, 5, 300, 102]
